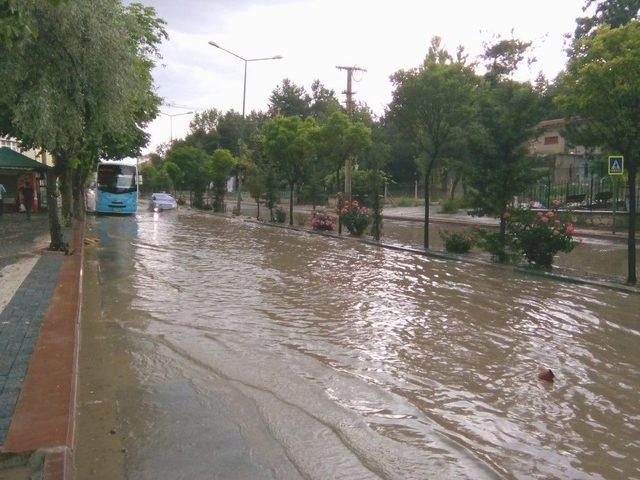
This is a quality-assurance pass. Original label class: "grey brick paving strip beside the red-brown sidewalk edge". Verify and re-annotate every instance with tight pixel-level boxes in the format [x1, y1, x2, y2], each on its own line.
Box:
[0, 255, 64, 444]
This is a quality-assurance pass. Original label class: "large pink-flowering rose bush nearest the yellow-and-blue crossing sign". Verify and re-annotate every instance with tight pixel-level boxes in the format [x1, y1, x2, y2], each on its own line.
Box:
[504, 204, 576, 268]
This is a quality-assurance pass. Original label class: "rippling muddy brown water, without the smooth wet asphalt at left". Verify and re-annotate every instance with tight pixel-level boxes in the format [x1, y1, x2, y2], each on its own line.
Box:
[96, 213, 640, 478]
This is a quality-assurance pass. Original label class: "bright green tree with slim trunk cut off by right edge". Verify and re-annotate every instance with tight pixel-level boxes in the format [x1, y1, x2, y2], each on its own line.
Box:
[558, 21, 640, 284]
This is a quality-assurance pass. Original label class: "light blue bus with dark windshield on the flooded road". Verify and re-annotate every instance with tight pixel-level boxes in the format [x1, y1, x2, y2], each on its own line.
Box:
[96, 159, 138, 215]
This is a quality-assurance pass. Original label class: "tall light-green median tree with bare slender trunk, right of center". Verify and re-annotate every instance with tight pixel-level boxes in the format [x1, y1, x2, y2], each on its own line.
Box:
[384, 37, 478, 248]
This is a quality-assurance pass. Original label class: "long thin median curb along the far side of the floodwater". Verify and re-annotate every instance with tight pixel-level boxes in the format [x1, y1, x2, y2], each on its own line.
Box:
[236, 214, 640, 295]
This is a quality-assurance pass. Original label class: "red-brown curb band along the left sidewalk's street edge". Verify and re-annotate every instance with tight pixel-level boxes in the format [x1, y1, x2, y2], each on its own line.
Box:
[3, 222, 84, 480]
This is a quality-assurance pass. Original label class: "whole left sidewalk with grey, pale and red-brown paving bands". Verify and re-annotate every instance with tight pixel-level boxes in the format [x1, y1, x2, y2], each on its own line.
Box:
[0, 214, 83, 480]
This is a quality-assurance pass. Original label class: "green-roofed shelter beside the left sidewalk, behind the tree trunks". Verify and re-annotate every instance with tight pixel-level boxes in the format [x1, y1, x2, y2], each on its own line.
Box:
[0, 147, 50, 212]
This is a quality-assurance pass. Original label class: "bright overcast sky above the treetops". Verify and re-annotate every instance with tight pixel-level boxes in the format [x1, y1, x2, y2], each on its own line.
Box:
[142, 0, 584, 151]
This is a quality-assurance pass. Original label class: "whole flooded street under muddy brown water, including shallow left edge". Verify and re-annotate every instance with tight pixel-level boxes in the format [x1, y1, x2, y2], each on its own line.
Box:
[77, 210, 640, 479]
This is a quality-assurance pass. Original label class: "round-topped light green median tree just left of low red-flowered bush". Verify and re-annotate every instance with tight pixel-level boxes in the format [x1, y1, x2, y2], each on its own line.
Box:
[264, 116, 317, 225]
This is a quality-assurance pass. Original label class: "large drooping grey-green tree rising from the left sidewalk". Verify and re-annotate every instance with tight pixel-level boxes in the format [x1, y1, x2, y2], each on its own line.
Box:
[0, 0, 166, 249]
